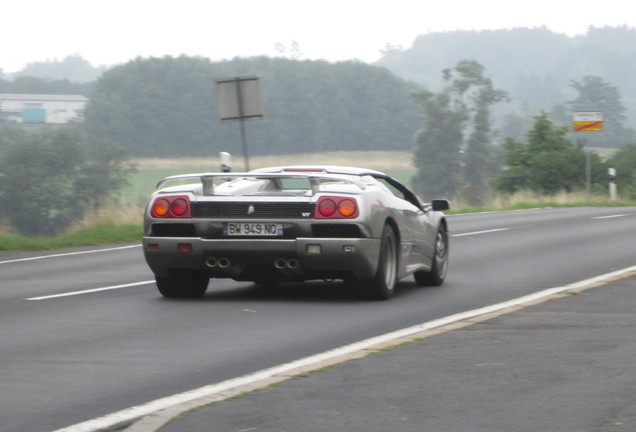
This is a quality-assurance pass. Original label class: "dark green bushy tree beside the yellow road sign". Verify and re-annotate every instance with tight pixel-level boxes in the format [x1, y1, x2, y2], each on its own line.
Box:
[494, 113, 607, 195]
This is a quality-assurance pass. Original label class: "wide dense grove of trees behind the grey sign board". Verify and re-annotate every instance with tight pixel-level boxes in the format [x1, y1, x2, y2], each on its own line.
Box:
[85, 56, 417, 157]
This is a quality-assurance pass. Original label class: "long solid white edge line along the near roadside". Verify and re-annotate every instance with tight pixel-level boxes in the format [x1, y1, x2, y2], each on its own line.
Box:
[53, 266, 636, 432]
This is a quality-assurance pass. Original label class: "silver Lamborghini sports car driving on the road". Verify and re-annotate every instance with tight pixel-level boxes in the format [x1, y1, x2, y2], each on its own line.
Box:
[143, 166, 449, 300]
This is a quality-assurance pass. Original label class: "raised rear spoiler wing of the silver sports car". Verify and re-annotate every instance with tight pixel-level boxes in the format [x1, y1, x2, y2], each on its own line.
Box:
[156, 172, 367, 196]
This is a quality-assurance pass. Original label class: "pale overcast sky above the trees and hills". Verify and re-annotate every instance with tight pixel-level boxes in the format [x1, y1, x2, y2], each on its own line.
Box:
[0, 0, 636, 73]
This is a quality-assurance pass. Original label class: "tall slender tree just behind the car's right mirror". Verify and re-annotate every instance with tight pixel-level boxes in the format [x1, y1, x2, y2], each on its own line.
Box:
[413, 60, 506, 205]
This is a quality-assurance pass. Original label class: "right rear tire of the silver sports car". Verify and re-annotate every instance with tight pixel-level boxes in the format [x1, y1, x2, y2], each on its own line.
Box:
[357, 225, 398, 300]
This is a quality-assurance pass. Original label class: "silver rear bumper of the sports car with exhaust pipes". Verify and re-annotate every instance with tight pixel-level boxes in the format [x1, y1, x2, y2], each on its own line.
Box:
[143, 237, 380, 280]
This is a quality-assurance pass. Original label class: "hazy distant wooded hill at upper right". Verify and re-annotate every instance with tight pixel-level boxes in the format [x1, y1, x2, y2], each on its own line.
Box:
[376, 26, 636, 128]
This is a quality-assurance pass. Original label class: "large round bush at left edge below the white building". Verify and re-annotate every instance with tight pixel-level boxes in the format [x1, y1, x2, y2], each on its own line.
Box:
[0, 128, 134, 236]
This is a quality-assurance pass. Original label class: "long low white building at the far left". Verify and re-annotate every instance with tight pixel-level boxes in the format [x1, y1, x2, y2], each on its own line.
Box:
[0, 93, 88, 124]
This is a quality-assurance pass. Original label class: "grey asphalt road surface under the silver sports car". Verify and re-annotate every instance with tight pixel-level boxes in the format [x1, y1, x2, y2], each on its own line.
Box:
[0, 208, 636, 432]
